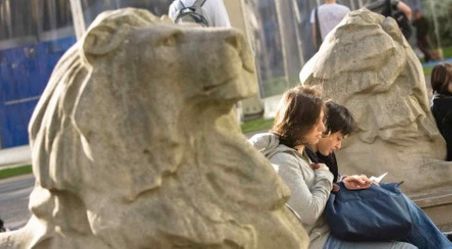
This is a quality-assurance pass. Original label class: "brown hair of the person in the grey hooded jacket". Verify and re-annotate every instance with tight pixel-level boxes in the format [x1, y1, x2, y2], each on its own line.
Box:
[270, 86, 324, 148]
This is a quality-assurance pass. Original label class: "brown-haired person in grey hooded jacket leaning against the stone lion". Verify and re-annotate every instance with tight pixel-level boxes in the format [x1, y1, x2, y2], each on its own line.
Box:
[249, 86, 416, 249]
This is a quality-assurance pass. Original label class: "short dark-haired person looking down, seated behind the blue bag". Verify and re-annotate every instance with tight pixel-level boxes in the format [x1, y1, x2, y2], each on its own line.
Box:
[306, 101, 452, 249]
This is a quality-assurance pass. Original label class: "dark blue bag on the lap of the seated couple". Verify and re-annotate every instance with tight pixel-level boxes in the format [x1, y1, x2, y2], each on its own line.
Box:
[325, 183, 412, 241]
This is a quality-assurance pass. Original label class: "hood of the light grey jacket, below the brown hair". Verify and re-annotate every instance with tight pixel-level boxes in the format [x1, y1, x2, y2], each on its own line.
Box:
[248, 132, 296, 158]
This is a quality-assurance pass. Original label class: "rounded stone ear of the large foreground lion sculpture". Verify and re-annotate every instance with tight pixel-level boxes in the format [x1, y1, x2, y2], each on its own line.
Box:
[83, 25, 129, 57]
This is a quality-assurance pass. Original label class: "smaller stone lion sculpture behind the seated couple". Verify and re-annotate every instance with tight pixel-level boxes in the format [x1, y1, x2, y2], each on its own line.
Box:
[300, 9, 452, 194]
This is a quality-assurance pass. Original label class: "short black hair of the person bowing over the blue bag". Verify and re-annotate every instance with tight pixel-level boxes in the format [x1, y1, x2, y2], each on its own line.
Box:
[325, 100, 356, 136]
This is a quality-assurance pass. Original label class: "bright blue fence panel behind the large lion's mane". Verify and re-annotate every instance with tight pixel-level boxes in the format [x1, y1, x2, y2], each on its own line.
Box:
[0, 36, 76, 148]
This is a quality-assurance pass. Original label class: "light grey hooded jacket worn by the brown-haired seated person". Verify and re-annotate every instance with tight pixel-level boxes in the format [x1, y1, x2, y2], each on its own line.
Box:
[249, 133, 333, 248]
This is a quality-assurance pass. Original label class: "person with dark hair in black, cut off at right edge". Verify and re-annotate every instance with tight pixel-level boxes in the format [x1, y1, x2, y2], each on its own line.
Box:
[430, 63, 452, 161]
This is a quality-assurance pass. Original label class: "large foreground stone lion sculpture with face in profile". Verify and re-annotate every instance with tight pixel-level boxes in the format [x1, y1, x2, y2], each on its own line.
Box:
[0, 9, 308, 249]
